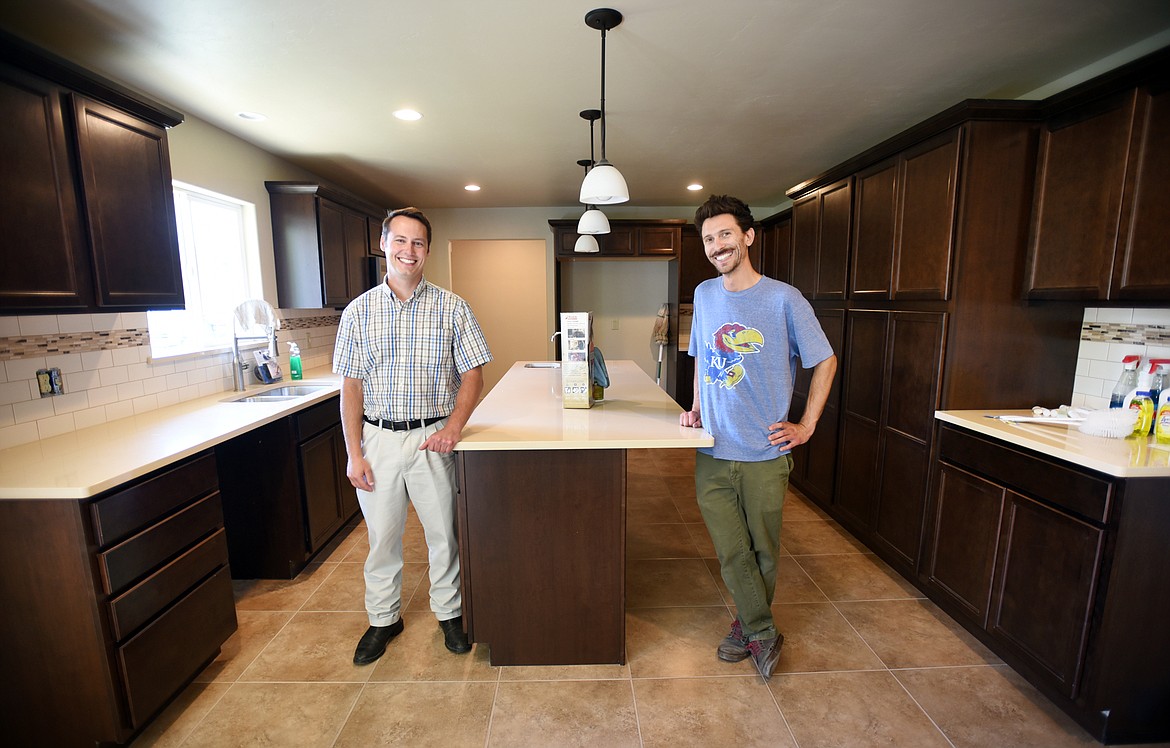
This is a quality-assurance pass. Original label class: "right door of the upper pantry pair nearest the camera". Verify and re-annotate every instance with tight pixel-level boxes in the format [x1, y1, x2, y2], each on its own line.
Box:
[894, 128, 963, 300]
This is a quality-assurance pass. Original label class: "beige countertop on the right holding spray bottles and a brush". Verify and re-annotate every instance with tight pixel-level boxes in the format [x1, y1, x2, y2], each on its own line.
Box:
[935, 411, 1170, 478]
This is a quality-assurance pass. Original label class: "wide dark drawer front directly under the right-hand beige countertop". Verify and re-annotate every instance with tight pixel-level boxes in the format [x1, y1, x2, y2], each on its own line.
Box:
[938, 426, 1113, 523]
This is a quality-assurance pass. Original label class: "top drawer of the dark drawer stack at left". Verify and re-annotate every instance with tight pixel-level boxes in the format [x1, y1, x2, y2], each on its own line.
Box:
[90, 453, 219, 547]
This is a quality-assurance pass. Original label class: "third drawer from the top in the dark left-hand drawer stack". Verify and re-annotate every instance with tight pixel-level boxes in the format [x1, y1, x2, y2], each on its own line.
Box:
[110, 529, 227, 641]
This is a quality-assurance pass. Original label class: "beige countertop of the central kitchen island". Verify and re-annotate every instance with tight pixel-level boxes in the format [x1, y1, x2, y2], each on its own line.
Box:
[455, 361, 715, 451]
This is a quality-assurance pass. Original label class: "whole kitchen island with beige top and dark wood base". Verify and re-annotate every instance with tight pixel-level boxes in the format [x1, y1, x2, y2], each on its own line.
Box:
[455, 361, 714, 665]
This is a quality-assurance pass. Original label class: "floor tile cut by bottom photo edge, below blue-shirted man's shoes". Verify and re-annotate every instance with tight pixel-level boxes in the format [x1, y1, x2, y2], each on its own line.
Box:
[634, 677, 796, 748]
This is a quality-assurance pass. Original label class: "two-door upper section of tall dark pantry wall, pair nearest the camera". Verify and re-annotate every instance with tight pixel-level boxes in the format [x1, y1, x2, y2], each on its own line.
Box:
[849, 128, 963, 300]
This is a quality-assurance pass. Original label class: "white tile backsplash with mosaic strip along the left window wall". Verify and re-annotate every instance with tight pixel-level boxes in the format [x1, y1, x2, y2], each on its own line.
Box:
[0, 309, 340, 450]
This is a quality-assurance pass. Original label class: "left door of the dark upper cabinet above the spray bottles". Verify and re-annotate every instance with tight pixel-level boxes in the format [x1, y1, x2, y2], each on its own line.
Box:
[1025, 91, 1135, 298]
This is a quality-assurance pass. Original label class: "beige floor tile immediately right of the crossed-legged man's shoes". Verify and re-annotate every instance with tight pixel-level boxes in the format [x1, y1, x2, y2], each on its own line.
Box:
[772, 603, 883, 673]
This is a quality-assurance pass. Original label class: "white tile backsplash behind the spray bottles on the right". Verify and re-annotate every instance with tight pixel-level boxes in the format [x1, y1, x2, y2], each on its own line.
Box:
[1071, 309, 1170, 409]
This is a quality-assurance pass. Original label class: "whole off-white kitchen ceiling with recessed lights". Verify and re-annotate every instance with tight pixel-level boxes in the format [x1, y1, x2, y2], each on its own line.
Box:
[0, 0, 1170, 215]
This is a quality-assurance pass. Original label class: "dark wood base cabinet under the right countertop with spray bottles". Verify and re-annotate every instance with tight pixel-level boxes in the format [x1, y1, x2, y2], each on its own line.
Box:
[922, 424, 1170, 744]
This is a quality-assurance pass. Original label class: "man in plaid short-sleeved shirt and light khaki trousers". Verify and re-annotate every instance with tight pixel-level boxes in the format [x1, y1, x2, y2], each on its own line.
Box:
[333, 207, 491, 665]
